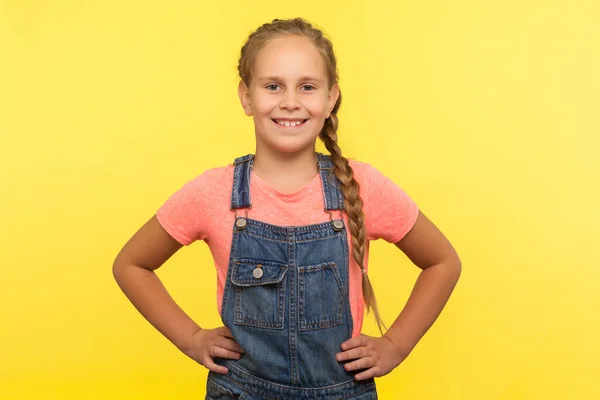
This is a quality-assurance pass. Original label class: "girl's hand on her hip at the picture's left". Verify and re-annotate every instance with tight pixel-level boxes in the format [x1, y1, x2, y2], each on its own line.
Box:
[187, 326, 244, 374]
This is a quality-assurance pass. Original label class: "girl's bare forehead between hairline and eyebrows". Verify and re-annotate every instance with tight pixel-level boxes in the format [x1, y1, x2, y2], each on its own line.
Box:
[253, 36, 326, 79]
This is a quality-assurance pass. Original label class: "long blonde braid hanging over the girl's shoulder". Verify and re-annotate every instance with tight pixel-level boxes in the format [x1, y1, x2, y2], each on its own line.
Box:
[319, 93, 387, 335]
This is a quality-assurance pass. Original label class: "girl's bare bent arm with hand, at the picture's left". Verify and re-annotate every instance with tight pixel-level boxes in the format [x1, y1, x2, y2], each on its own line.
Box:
[113, 216, 243, 373]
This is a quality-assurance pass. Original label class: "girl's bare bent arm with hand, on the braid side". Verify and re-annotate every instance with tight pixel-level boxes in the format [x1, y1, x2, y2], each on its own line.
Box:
[337, 212, 462, 379]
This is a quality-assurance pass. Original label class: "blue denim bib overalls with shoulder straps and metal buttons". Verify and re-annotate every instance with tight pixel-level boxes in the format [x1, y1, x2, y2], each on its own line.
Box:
[206, 153, 377, 400]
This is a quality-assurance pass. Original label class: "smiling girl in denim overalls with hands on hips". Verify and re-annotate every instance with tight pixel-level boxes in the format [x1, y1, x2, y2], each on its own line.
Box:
[113, 19, 461, 400]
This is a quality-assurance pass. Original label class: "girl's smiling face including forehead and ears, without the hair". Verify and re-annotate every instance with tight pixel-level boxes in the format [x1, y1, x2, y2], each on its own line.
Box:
[238, 36, 339, 153]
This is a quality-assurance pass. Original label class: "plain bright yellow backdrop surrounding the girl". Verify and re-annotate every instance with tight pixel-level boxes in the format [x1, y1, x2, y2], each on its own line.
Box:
[0, 0, 600, 400]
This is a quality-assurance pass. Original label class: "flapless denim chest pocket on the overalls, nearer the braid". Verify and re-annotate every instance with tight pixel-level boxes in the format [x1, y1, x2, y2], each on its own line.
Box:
[298, 262, 346, 331]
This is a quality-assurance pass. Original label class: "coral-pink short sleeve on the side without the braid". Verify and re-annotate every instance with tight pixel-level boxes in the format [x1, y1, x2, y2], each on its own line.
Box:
[156, 171, 218, 246]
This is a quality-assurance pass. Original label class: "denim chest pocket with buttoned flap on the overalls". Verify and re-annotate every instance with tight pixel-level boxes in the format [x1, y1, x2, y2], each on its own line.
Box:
[231, 260, 288, 329]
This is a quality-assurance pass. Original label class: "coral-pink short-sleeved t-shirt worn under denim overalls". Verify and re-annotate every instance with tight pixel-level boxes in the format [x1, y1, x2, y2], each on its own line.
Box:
[156, 160, 419, 337]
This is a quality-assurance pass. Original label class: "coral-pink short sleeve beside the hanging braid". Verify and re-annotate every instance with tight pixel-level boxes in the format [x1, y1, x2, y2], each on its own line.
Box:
[352, 162, 419, 243]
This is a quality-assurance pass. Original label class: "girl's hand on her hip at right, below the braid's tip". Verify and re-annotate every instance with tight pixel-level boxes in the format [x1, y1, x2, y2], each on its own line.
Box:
[335, 335, 408, 380]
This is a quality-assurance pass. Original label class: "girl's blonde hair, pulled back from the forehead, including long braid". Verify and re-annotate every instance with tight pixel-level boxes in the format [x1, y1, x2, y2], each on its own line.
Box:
[238, 18, 385, 335]
